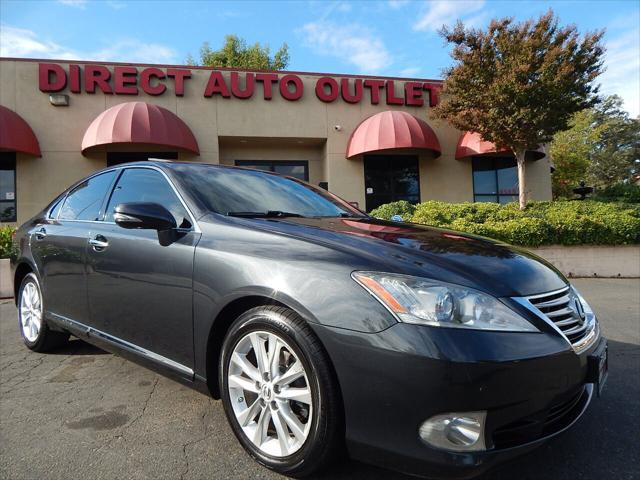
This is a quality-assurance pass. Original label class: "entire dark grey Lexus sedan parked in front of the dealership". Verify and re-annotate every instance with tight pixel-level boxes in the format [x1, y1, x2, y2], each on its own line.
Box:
[12, 161, 607, 478]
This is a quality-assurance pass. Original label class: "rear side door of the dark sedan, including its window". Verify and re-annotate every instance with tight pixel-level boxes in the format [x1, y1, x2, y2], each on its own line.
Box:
[30, 170, 116, 324]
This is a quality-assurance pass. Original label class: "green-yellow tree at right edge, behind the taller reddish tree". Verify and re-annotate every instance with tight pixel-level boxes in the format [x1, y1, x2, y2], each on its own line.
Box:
[549, 95, 640, 197]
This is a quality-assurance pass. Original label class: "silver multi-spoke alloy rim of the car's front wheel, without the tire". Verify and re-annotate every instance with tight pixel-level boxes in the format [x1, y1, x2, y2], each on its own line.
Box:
[227, 331, 313, 457]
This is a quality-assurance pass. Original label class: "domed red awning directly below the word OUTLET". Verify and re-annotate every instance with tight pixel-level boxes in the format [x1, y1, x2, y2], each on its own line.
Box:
[347, 111, 441, 158]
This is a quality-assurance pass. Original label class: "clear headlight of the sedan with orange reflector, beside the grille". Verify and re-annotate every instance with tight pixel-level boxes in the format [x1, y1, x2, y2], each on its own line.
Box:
[352, 272, 539, 332]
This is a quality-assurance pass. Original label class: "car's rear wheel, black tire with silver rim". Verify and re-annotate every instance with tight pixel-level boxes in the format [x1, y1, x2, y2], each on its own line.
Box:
[18, 273, 69, 352]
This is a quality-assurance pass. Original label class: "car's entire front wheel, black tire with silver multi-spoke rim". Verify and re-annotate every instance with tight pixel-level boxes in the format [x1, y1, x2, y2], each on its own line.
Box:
[218, 306, 344, 477]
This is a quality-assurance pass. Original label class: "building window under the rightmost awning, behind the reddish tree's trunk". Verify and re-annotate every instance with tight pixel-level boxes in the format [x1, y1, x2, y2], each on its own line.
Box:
[472, 157, 518, 203]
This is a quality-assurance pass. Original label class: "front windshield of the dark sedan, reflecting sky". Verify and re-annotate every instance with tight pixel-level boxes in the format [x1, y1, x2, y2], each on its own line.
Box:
[172, 165, 364, 217]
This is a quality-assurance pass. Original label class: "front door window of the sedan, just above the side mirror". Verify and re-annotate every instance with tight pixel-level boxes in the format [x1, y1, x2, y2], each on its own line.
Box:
[105, 168, 191, 228]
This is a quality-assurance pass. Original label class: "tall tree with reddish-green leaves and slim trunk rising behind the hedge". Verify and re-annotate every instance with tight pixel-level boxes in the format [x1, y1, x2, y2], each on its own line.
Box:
[434, 10, 604, 208]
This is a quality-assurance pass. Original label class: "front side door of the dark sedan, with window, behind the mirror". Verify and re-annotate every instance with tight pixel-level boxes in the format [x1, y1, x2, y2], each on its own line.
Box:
[87, 167, 200, 377]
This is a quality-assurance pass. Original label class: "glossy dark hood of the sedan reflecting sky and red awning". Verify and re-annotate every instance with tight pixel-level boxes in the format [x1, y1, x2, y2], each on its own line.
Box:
[224, 217, 567, 297]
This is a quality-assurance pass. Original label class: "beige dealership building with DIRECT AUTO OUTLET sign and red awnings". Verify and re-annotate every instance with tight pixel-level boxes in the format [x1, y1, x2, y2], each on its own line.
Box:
[0, 58, 551, 223]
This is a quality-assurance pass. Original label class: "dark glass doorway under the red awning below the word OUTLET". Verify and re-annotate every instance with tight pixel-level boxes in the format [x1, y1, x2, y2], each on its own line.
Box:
[364, 155, 420, 212]
